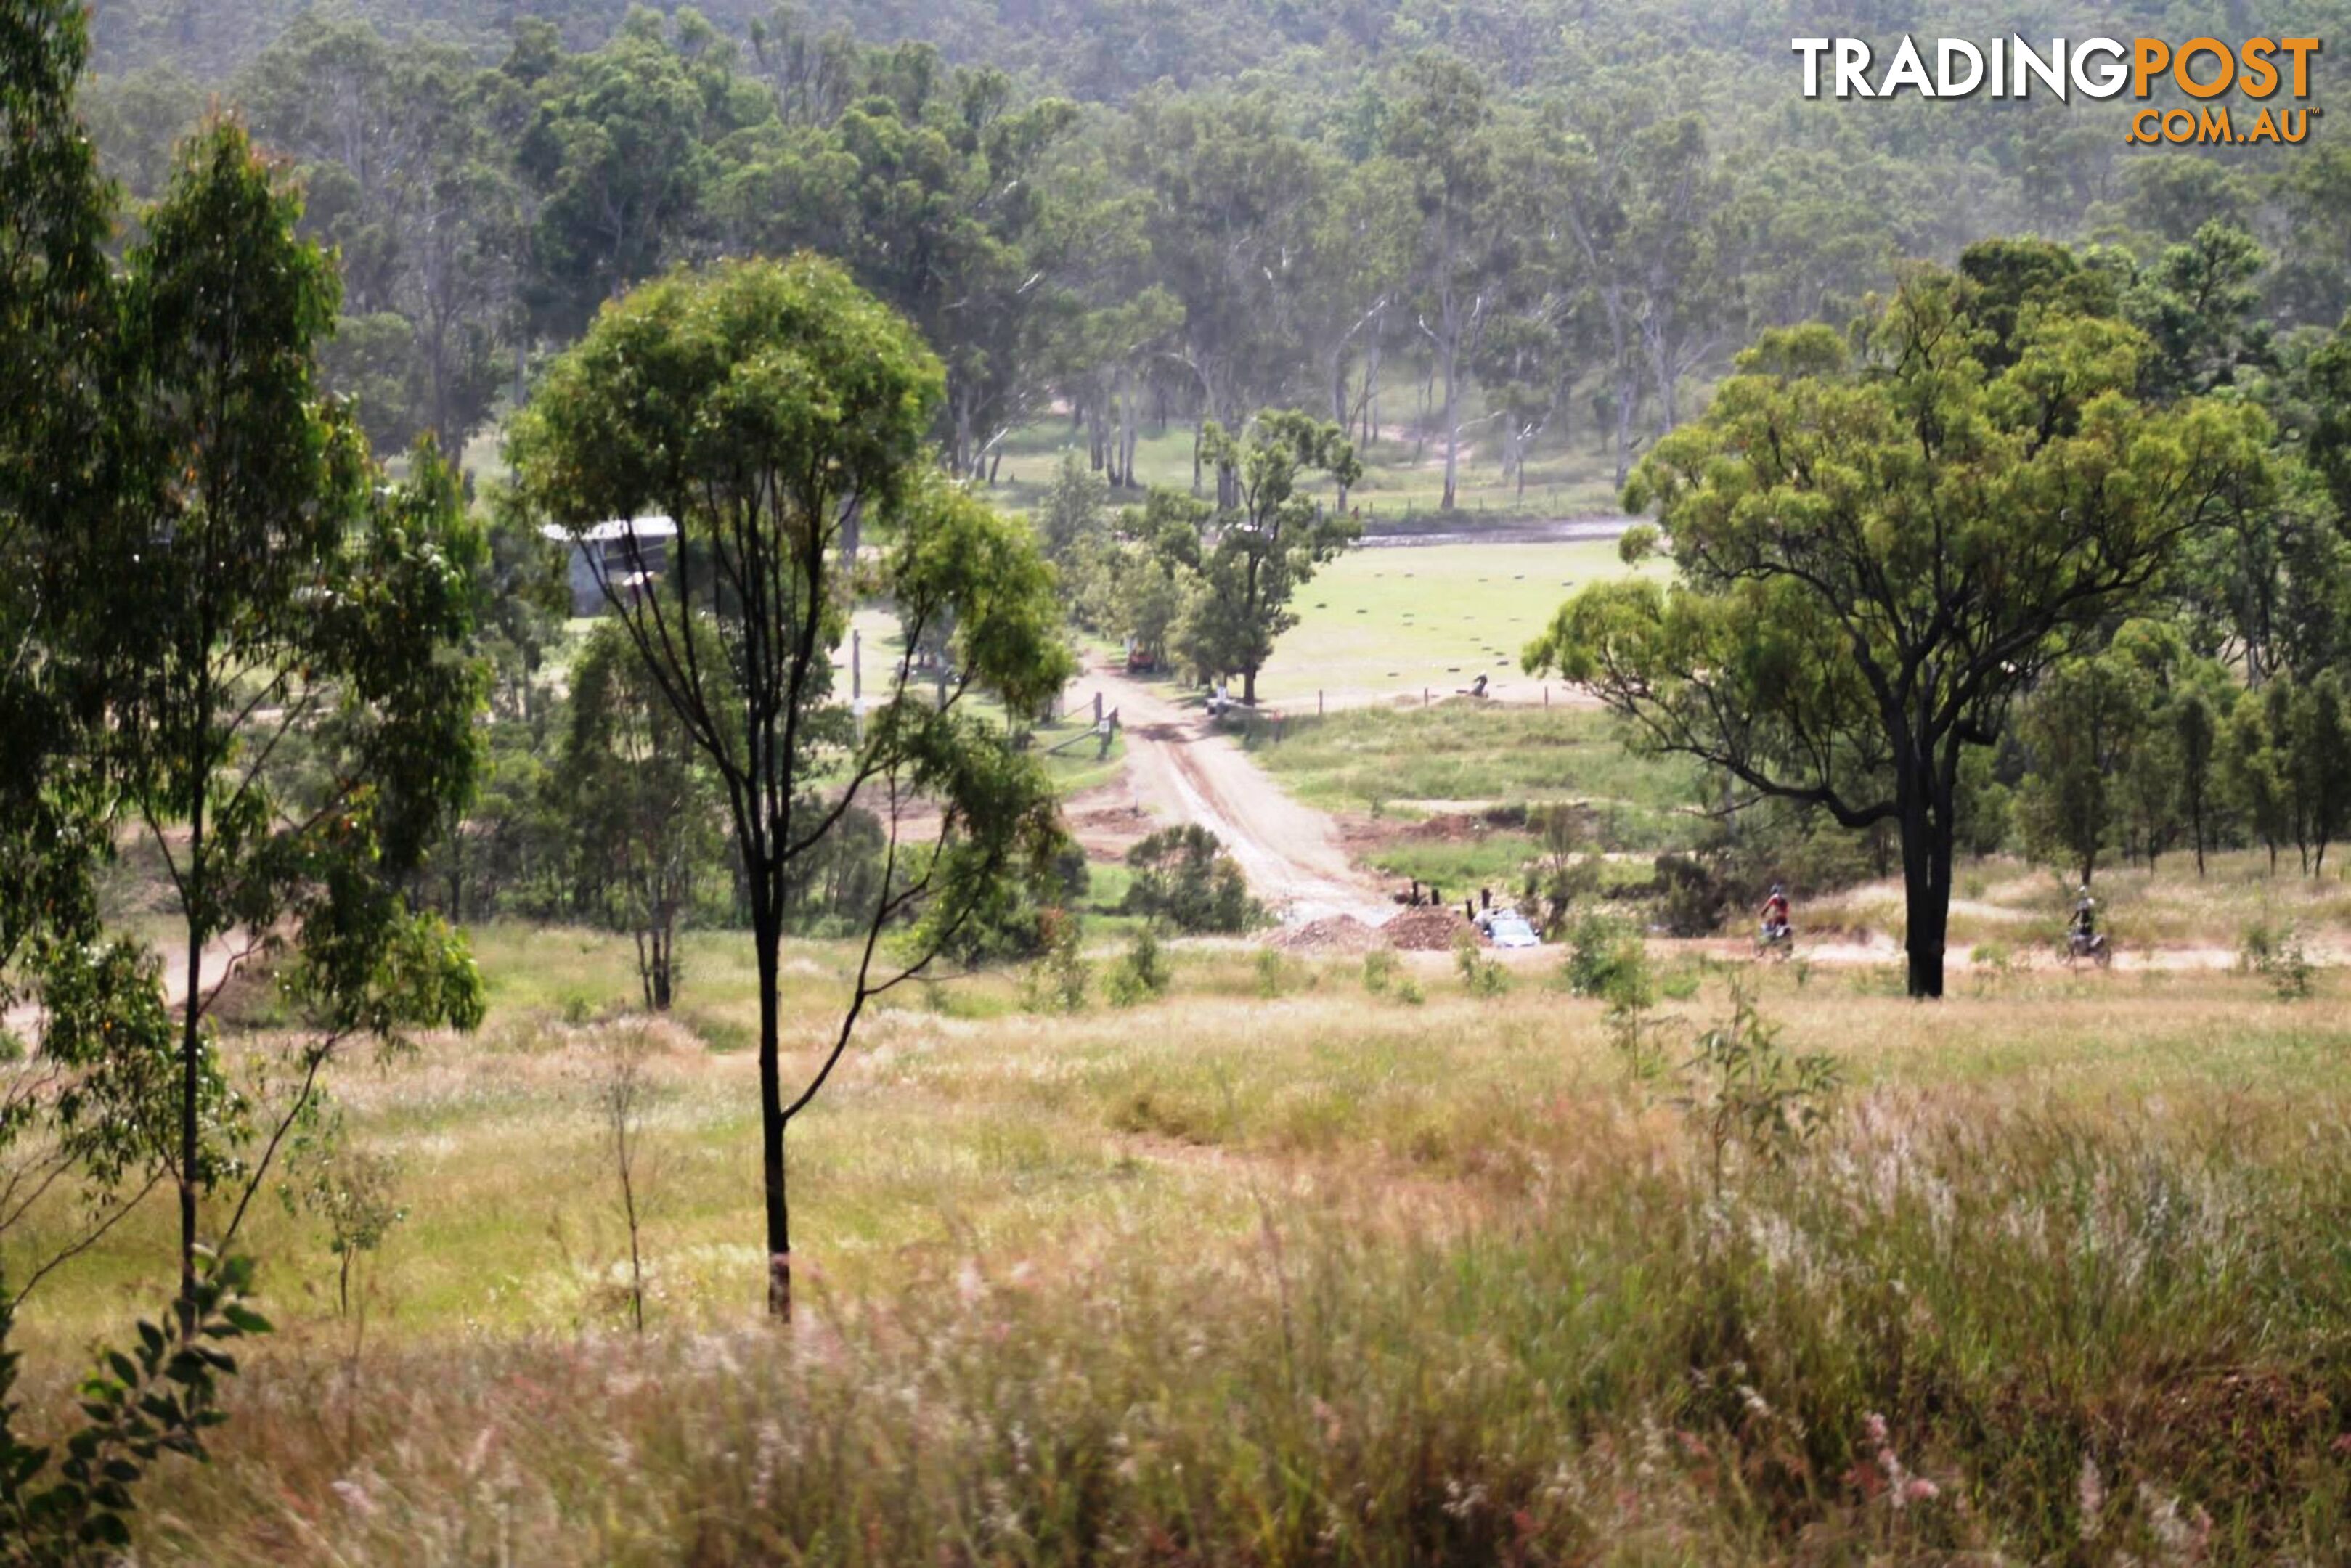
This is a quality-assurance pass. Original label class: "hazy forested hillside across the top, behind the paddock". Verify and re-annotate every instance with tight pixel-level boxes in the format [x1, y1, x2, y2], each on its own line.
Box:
[85, 0, 2351, 503]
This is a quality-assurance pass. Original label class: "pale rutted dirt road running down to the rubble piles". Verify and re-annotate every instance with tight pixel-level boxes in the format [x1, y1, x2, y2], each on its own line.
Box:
[1069, 665, 1394, 924]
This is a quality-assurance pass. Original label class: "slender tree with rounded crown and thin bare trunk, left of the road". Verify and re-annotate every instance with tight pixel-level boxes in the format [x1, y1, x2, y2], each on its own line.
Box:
[513, 256, 1069, 1319]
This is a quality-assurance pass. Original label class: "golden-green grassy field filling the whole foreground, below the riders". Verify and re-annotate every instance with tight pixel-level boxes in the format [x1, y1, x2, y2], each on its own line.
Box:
[26, 931, 2351, 1564]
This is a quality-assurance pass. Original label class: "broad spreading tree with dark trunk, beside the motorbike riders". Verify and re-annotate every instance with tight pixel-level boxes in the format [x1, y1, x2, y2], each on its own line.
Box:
[1525, 270, 2269, 997]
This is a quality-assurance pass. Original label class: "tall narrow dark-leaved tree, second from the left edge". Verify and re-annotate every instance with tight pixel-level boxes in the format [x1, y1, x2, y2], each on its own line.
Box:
[95, 120, 482, 1331]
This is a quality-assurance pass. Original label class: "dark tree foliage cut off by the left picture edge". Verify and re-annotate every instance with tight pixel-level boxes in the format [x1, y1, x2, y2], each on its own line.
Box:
[0, 2, 149, 1335]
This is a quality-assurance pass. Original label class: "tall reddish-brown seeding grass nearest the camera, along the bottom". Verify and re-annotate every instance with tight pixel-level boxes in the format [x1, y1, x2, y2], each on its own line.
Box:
[101, 1088, 2351, 1564]
